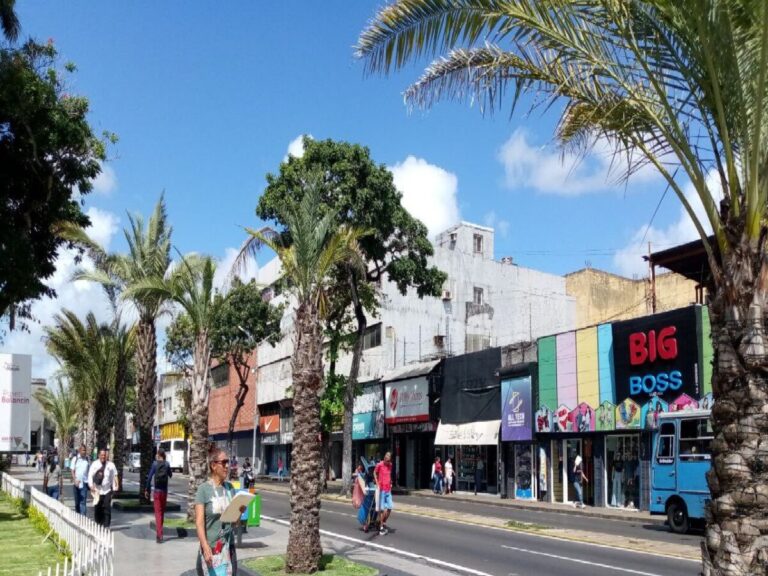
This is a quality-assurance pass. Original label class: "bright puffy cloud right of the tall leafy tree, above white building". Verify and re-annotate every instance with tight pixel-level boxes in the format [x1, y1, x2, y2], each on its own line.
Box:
[389, 156, 460, 237]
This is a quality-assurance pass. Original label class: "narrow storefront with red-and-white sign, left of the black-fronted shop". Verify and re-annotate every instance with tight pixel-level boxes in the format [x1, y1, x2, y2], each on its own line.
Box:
[380, 360, 440, 488]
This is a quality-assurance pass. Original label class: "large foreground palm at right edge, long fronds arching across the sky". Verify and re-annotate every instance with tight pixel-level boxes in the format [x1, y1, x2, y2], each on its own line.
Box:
[357, 0, 768, 574]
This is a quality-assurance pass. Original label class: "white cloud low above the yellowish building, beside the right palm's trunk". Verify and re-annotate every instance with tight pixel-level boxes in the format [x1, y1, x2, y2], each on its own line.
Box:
[613, 172, 722, 277]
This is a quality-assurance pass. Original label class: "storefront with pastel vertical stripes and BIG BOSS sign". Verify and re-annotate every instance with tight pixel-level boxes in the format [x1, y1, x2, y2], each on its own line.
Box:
[533, 306, 711, 510]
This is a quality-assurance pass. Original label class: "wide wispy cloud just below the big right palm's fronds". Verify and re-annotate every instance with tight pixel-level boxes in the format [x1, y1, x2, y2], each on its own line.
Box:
[498, 130, 658, 196]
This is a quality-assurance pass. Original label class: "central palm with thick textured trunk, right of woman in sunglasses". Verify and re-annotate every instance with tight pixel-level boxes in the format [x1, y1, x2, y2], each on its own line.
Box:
[238, 175, 365, 574]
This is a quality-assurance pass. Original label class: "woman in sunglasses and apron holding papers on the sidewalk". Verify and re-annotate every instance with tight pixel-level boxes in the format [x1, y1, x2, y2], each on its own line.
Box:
[195, 447, 245, 576]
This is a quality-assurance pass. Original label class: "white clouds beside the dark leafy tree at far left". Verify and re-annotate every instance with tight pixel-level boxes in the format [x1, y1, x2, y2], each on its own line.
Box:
[2, 208, 119, 378]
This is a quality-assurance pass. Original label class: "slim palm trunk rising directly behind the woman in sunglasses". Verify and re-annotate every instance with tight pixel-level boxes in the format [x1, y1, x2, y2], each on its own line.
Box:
[187, 332, 210, 521]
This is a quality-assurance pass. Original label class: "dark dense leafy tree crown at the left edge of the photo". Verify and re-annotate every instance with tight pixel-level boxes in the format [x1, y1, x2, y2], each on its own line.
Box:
[0, 39, 105, 329]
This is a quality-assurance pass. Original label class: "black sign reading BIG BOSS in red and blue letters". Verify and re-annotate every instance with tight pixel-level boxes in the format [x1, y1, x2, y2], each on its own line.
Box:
[613, 307, 699, 405]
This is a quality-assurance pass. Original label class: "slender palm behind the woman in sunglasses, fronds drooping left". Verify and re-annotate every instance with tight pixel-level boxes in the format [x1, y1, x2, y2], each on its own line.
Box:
[125, 255, 216, 520]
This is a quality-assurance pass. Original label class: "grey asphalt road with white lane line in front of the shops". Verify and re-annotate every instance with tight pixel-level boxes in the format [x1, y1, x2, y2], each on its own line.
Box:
[124, 475, 699, 576]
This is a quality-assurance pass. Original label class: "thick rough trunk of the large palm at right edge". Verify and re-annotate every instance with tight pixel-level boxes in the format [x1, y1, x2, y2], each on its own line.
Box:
[702, 236, 768, 576]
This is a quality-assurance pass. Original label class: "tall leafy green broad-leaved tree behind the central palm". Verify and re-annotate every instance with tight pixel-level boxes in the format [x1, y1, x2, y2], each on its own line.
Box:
[256, 137, 446, 494]
